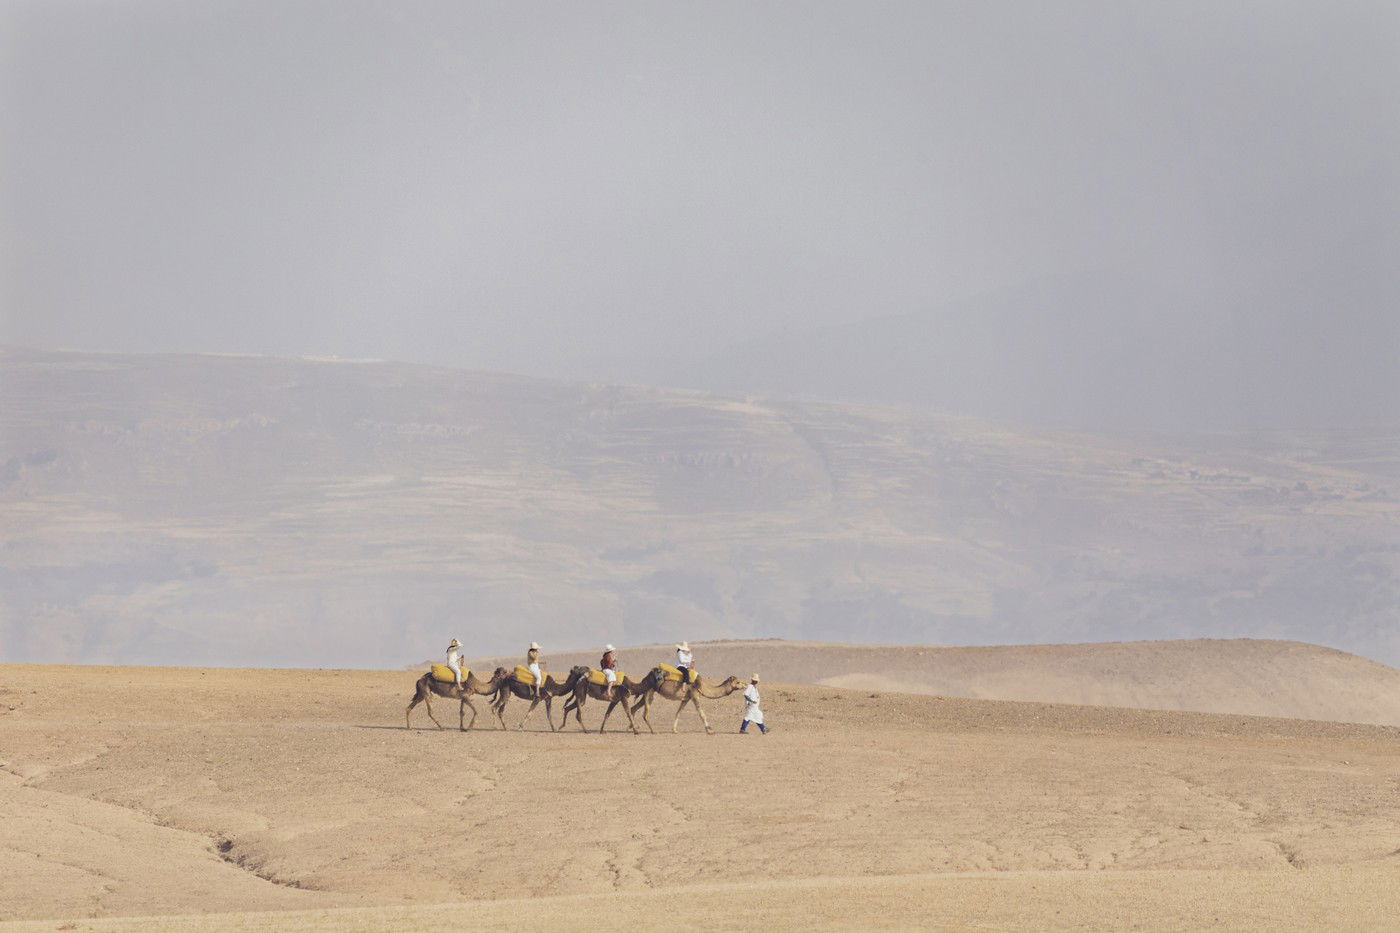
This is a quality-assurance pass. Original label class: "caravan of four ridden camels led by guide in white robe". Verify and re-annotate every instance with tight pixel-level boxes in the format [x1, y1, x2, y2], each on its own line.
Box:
[403, 639, 763, 735]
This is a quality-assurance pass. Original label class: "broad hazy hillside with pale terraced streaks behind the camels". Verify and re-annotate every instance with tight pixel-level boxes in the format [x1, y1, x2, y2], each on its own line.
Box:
[0, 349, 1400, 665]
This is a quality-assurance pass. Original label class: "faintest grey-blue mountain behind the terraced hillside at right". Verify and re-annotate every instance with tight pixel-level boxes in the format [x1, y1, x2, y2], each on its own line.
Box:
[650, 275, 1400, 431]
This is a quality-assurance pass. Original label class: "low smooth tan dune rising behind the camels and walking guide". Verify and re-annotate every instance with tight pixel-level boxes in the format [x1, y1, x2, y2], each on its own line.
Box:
[473, 639, 1400, 726]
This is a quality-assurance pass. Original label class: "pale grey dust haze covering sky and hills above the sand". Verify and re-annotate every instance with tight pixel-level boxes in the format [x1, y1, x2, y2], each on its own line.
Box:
[0, 1, 1400, 665]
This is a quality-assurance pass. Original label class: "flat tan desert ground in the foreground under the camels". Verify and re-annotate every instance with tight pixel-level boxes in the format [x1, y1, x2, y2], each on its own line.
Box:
[0, 647, 1400, 930]
